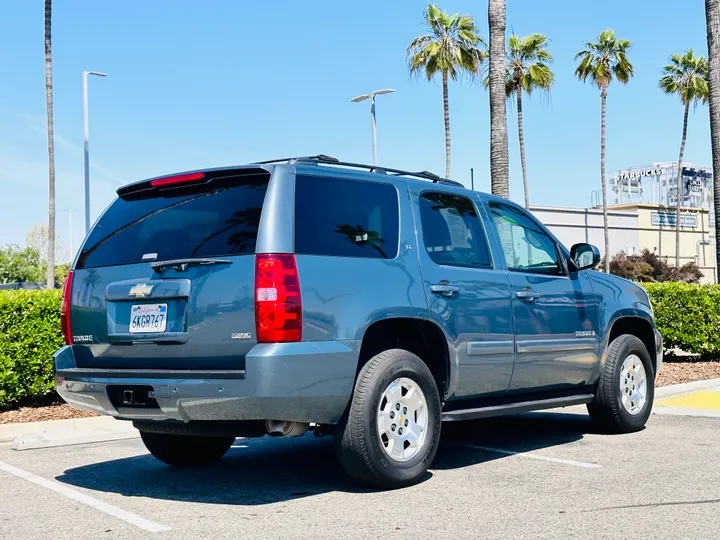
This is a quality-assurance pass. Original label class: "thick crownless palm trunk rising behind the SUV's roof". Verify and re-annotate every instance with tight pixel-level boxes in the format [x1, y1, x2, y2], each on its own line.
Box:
[488, 0, 510, 199]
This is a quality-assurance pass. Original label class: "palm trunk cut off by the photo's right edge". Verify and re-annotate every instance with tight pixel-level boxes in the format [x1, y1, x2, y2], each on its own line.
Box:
[705, 0, 720, 282]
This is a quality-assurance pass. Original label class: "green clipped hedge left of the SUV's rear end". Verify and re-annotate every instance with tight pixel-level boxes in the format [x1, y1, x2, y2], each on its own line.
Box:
[0, 290, 64, 407]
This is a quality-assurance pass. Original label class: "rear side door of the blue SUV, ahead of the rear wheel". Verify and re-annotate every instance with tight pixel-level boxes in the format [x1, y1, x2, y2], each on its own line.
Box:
[410, 188, 514, 398]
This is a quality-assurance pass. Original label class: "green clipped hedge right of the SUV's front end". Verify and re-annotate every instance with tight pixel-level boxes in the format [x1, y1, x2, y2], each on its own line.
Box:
[642, 282, 720, 357]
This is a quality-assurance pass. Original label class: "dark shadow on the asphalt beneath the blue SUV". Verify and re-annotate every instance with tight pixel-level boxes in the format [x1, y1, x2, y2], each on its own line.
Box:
[56, 413, 591, 506]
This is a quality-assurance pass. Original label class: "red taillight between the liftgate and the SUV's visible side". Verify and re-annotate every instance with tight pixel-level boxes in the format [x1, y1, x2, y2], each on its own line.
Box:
[255, 254, 302, 343]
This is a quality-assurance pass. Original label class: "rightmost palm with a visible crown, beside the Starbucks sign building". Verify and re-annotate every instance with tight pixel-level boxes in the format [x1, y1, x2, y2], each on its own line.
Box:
[660, 49, 708, 268]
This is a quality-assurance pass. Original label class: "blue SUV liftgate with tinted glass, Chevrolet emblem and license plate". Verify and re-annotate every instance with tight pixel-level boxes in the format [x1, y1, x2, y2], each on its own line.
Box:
[71, 169, 270, 370]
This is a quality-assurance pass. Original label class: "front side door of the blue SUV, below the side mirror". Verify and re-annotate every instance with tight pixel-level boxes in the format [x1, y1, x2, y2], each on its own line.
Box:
[488, 201, 600, 390]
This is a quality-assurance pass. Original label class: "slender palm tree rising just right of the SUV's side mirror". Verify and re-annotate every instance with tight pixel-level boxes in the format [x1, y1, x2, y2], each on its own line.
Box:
[575, 29, 634, 273]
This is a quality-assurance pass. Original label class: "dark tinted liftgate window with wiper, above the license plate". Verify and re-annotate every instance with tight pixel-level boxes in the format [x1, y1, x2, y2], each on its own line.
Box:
[77, 174, 269, 268]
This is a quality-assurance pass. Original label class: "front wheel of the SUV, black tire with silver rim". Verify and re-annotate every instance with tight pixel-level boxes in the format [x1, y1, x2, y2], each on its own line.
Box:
[588, 334, 655, 433]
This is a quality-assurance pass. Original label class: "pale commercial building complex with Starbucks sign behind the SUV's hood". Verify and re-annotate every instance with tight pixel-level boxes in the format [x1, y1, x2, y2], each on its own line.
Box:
[530, 162, 716, 282]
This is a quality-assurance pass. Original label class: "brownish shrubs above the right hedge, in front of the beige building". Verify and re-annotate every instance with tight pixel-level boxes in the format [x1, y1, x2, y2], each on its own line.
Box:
[610, 249, 703, 283]
